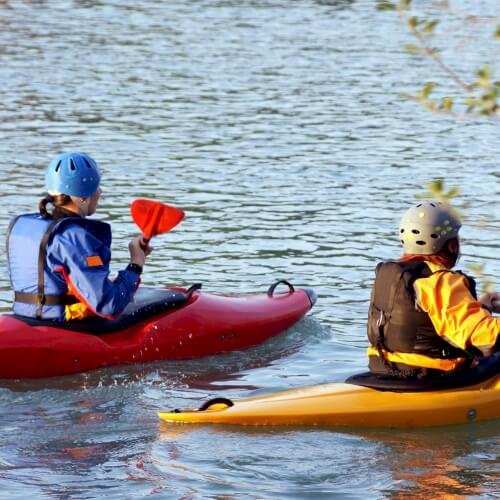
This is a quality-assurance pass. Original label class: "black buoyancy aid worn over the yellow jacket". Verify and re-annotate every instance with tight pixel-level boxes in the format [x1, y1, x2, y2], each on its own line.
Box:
[368, 261, 476, 359]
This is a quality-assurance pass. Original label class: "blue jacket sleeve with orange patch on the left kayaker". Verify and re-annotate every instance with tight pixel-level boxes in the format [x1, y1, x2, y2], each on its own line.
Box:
[48, 225, 140, 319]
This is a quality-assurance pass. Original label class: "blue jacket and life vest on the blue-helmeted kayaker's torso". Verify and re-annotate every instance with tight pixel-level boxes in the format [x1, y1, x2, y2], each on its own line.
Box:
[7, 214, 140, 321]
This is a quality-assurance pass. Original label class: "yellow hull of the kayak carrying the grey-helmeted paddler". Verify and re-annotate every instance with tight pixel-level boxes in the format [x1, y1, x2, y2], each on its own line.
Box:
[158, 375, 500, 428]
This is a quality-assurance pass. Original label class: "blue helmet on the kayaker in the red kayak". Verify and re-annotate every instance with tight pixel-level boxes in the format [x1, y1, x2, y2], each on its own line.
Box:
[45, 153, 101, 198]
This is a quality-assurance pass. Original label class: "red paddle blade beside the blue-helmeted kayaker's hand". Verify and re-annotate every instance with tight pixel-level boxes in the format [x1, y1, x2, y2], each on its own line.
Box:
[130, 198, 184, 244]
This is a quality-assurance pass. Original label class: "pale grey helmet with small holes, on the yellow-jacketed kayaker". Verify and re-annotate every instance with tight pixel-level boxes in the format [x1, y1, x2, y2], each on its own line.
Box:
[399, 201, 462, 255]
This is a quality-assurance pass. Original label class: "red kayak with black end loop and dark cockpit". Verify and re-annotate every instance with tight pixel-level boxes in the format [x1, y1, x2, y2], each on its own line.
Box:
[0, 282, 316, 379]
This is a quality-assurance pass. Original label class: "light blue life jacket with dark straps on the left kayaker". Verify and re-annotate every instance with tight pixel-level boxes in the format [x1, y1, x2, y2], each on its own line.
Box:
[7, 213, 111, 320]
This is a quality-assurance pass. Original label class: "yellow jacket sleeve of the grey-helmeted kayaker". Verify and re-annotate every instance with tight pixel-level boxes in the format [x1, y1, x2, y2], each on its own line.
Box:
[414, 271, 500, 356]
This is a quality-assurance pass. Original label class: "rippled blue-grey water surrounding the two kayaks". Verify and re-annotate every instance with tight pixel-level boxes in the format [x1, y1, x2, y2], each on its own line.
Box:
[0, 0, 500, 498]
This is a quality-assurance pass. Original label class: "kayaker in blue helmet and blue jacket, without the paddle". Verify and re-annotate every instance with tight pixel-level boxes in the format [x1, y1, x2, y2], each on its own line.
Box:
[7, 152, 151, 321]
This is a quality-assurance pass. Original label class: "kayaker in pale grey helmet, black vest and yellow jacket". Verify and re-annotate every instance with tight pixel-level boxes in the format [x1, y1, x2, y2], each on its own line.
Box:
[368, 202, 500, 378]
